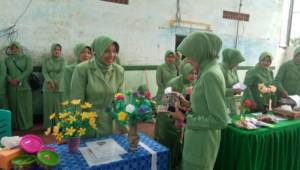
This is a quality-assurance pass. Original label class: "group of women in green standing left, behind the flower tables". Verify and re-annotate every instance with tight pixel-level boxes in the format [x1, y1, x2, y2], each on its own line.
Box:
[0, 36, 124, 135]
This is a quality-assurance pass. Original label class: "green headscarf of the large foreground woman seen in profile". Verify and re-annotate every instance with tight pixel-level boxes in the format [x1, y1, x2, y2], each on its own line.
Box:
[177, 32, 222, 68]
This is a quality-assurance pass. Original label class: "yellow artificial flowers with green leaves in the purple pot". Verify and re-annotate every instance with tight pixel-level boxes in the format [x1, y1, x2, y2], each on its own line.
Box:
[45, 100, 97, 143]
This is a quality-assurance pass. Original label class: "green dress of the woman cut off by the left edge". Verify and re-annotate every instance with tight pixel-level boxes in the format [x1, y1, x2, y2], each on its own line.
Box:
[0, 58, 7, 108]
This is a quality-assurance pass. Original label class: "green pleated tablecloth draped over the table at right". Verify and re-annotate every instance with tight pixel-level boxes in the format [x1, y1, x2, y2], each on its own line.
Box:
[214, 114, 300, 170]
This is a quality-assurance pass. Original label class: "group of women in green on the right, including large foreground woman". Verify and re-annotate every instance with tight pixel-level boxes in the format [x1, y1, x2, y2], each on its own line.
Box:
[155, 33, 300, 170]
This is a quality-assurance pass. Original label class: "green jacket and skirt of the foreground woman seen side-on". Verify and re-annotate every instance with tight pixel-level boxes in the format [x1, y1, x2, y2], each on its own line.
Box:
[183, 61, 227, 169]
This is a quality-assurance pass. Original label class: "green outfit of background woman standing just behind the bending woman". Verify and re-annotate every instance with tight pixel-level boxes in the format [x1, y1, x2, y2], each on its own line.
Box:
[156, 50, 178, 100]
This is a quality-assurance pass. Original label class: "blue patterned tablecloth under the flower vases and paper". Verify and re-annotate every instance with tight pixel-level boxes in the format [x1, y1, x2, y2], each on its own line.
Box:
[50, 133, 169, 170]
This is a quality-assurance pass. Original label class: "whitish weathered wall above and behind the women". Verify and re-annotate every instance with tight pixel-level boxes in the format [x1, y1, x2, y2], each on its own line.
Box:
[0, 0, 282, 65]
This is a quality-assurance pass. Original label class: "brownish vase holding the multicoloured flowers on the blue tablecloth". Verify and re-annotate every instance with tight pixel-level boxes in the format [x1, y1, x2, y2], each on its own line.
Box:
[128, 123, 140, 151]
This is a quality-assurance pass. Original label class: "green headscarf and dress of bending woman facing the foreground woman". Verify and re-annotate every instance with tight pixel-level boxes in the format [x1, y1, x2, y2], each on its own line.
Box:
[155, 64, 193, 169]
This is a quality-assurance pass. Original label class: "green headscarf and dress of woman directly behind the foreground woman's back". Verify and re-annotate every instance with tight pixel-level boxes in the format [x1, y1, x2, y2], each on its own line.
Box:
[220, 48, 245, 113]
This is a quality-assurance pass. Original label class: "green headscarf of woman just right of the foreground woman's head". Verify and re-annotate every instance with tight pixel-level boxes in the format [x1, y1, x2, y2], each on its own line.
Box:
[222, 48, 245, 66]
